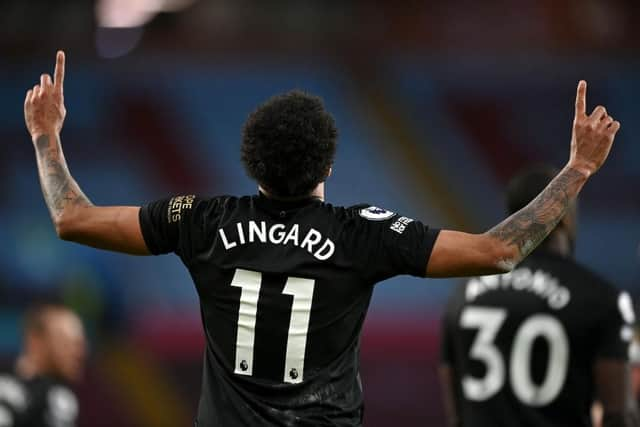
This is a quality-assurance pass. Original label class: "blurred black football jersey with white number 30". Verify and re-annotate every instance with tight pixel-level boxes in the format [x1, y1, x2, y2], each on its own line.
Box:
[442, 251, 634, 427]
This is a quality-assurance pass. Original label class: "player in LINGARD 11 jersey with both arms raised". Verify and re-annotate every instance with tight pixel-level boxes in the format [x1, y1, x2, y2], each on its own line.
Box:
[24, 52, 620, 427]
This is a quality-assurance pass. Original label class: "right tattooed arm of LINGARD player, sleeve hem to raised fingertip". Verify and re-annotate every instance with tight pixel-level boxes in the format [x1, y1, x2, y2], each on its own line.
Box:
[427, 81, 620, 277]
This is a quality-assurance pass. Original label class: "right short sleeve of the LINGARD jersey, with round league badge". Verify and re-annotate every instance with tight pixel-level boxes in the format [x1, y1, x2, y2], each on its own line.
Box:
[344, 206, 440, 282]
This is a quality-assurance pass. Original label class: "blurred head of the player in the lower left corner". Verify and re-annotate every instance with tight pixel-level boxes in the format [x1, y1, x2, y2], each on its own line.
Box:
[18, 304, 87, 382]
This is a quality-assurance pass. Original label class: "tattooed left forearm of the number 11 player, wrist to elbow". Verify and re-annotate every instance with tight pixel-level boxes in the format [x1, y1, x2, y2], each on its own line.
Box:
[35, 135, 92, 223]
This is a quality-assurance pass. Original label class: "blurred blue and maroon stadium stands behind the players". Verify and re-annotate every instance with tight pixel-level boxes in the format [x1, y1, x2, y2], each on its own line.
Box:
[0, 0, 640, 427]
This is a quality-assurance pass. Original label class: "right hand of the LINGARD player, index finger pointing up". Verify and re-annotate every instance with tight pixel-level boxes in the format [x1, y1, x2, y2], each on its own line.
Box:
[569, 80, 620, 177]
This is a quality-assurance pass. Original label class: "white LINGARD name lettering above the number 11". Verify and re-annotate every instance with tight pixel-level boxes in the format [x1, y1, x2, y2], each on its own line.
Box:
[218, 221, 336, 261]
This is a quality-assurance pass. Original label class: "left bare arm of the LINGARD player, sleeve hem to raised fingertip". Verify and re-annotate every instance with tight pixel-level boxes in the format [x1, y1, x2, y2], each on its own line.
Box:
[24, 52, 149, 255]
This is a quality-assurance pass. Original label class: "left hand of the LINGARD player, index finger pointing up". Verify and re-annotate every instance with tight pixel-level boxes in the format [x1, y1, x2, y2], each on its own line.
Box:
[24, 51, 67, 140]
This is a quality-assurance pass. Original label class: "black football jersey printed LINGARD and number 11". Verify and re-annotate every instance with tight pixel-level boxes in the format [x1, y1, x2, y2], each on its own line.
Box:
[140, 194, 438, 427]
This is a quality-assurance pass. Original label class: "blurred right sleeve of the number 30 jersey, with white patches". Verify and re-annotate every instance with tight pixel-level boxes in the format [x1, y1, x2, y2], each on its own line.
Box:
[596, 292, 635, 360]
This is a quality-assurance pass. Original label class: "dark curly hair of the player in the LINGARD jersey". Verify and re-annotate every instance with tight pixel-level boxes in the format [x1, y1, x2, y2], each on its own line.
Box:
[241, 90, 338, 198]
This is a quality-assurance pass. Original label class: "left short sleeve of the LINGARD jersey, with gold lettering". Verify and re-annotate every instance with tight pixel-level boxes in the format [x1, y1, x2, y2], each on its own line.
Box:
[139, 195, 217, 259]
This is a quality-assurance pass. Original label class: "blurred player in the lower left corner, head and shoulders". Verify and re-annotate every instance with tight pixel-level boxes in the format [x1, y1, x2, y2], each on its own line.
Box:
[0, 304, 86, 427]
